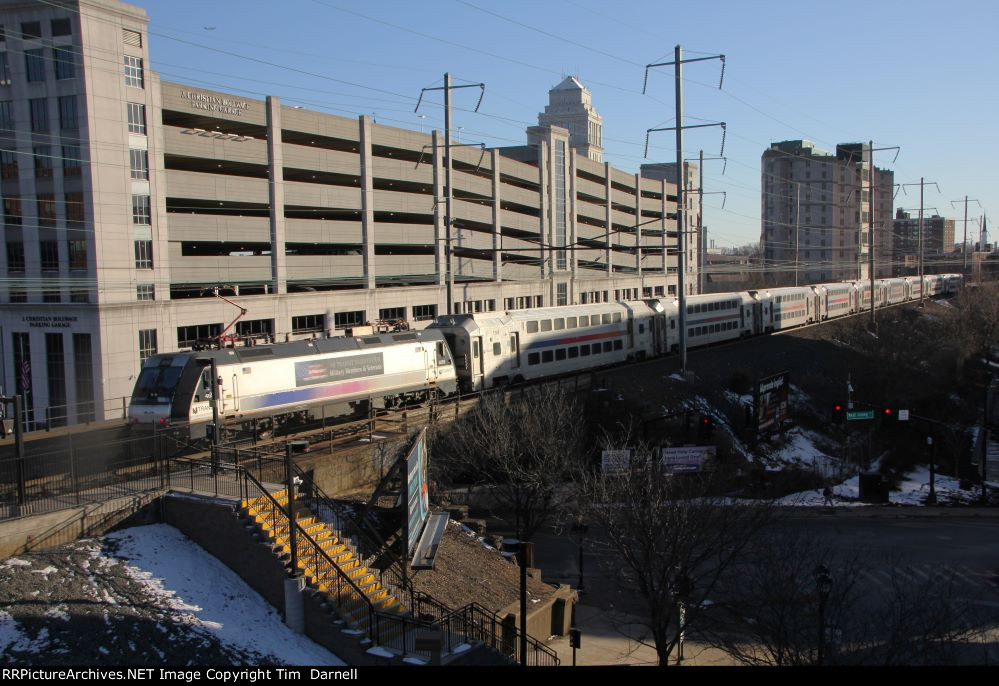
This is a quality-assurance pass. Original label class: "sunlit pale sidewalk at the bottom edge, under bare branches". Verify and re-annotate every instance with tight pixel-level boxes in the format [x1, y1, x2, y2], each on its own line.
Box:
[548, 595, 737, 667]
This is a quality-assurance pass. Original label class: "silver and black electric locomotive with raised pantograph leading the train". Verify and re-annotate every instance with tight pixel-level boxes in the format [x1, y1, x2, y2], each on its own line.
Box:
[129, 330, 456, 438]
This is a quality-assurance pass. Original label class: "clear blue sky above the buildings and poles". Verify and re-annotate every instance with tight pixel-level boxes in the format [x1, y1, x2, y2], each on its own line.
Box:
[145, 0, 999, 253]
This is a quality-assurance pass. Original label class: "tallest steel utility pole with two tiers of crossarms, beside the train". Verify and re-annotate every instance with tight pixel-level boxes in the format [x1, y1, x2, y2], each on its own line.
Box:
[642, 45, 725, 376]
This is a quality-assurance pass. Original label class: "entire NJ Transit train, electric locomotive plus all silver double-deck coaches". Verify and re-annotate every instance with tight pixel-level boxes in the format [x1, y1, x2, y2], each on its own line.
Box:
[129, 274, 962, 438]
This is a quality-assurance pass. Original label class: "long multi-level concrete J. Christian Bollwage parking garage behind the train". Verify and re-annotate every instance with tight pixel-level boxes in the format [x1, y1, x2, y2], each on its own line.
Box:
[0, 0, 696, 426]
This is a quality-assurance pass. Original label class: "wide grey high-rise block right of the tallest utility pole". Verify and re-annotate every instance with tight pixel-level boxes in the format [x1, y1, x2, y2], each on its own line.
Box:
[760, 140, 894, 284]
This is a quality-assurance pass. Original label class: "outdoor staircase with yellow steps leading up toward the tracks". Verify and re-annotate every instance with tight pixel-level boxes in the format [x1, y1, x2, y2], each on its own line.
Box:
[241, 489, 412, 653]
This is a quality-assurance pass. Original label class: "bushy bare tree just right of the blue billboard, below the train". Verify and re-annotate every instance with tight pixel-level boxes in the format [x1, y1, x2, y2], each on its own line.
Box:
[433, 385, 585, 541]
